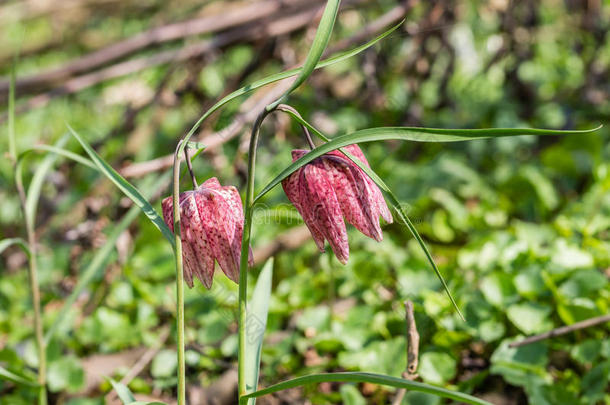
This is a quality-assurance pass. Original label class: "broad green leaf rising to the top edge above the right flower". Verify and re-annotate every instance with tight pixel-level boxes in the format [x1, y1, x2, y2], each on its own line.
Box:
[267, 0, 340, 111]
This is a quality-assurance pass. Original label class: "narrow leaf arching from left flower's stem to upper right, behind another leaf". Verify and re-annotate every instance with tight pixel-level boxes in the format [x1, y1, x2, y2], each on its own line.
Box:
[180, 20, 404, 148]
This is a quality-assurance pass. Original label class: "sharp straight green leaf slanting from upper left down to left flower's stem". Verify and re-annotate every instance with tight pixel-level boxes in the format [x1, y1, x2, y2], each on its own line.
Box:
[68, 125, 175, 248]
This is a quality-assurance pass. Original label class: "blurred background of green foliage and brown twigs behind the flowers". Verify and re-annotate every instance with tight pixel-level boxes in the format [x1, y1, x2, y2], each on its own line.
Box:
[0, 0, 610, 405]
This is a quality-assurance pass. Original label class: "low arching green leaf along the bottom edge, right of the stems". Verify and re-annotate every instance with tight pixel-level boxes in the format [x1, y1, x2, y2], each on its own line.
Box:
[239, 373, 491, 405]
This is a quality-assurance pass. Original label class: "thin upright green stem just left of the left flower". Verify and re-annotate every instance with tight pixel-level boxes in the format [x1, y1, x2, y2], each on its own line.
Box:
[172, 142, 186, 405]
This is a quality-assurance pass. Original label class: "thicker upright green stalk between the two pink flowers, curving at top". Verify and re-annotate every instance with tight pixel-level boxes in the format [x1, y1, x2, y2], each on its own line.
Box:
[237, 110, 270, 397]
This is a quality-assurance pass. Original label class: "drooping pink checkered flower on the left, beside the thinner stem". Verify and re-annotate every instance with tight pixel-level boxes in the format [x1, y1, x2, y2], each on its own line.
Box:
[161, 177, 252, 288]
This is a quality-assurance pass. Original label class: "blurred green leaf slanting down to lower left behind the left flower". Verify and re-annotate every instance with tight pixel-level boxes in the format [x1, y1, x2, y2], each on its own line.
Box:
[45, 171, 171, 343]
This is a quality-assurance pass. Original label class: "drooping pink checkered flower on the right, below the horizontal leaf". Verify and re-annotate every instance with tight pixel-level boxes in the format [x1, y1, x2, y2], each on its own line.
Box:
[282, 145, 392, 264]
